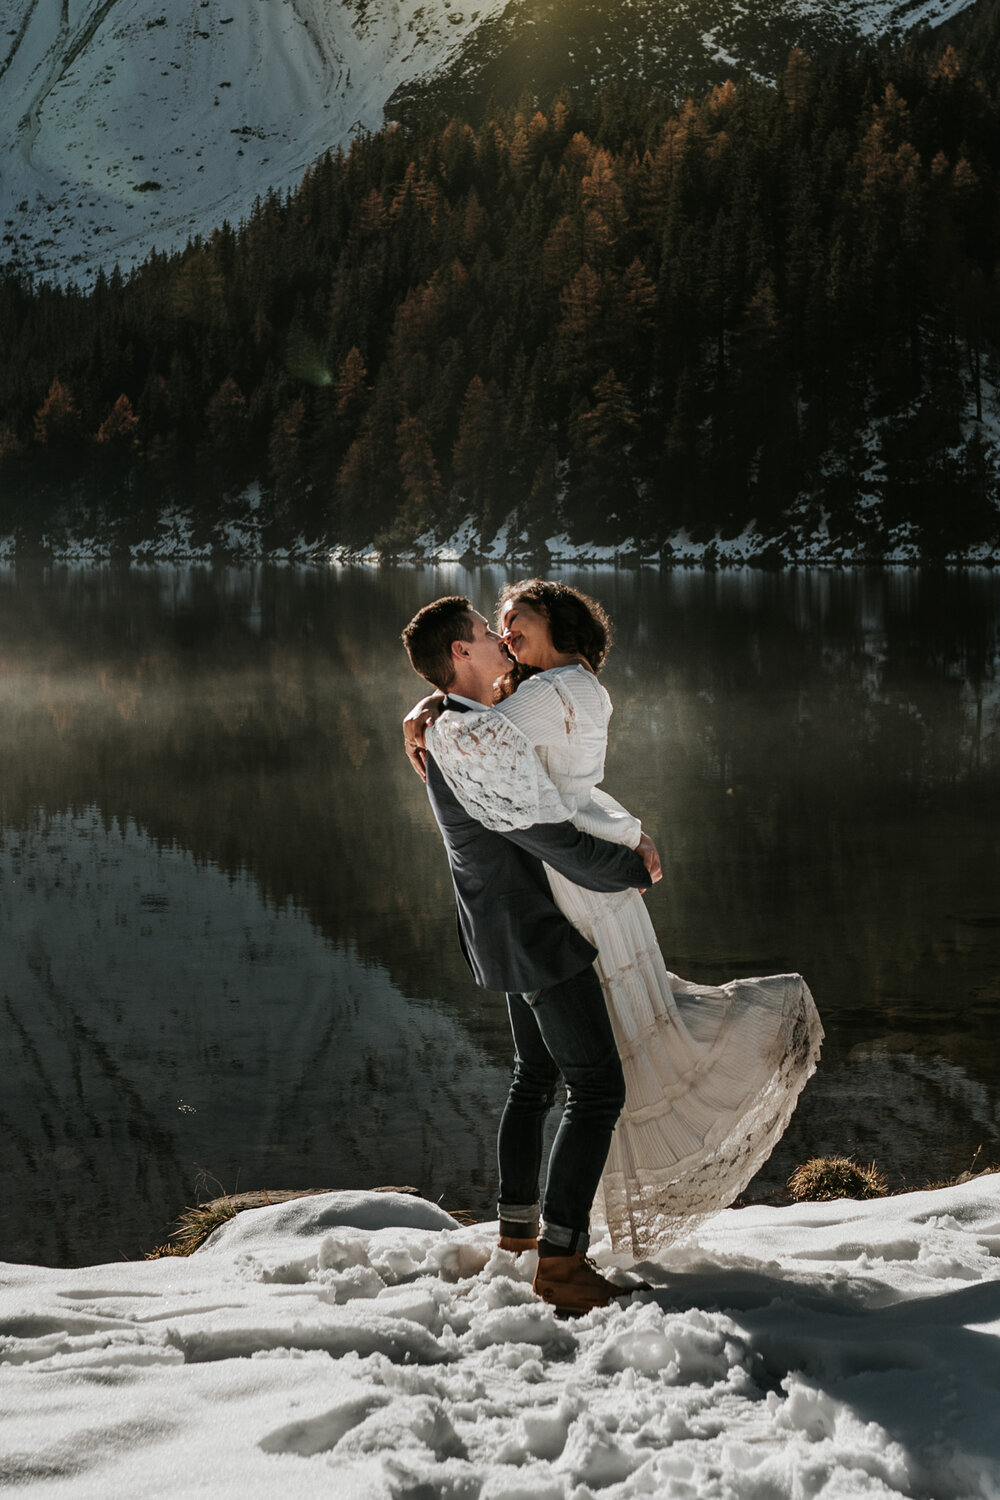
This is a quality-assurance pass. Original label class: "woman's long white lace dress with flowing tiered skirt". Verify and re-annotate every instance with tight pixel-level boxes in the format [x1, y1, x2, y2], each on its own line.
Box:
[429, 666, 823, 1259]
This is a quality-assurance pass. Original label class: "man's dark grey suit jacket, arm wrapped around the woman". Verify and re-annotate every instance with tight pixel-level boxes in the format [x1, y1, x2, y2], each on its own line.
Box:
[427, 704, 649, 995]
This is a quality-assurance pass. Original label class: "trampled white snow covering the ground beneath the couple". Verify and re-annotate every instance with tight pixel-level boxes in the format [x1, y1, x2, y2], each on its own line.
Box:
[0, 1176, 1000, 1500]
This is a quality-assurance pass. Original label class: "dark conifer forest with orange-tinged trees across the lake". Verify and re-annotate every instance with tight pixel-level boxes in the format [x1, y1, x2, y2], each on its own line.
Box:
[0, 8, 1000, 560]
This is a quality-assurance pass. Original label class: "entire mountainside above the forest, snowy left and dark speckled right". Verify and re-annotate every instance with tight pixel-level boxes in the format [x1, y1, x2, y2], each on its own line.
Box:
[0, 0, 969, 284]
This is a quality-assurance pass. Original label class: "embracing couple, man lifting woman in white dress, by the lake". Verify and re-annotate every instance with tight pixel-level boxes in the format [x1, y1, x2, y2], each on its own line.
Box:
[403, 579, 823, 1314]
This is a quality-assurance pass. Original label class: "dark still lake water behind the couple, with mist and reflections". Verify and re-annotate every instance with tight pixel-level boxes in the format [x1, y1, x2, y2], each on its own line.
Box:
[0, 564, 1000, 1265]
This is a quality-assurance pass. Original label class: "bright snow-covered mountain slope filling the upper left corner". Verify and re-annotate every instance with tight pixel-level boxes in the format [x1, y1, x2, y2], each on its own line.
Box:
[0, 0, 509, 281]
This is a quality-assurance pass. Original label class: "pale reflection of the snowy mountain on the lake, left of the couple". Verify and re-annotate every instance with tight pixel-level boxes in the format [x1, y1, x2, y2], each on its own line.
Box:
[0, 809, 504, 1265]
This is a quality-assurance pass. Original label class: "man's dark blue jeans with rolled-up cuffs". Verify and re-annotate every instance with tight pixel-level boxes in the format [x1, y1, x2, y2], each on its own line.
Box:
[496, 968, 625, 1250]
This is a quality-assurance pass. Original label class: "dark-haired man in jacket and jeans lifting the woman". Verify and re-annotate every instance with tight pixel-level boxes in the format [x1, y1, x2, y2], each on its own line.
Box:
[403, 596, 660, 1313]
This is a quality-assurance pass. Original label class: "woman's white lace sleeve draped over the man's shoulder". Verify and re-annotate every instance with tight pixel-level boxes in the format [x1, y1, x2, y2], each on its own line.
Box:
[427, 710, 573, 833]
